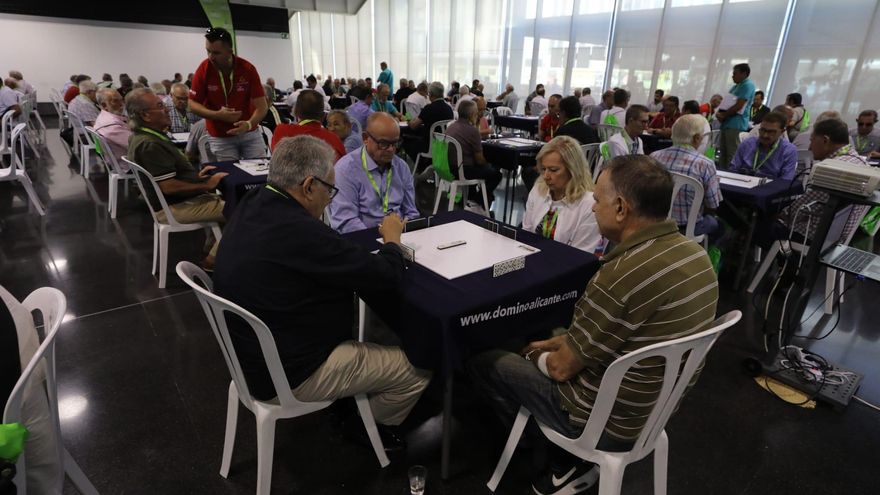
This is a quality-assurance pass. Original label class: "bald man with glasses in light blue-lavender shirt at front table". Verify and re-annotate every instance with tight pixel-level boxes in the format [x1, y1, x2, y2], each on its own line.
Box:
[330, 112, 419, 233]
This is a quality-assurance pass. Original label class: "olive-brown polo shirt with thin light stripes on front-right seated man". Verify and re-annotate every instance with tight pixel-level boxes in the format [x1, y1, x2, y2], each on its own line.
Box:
[558, 220, 718, 440]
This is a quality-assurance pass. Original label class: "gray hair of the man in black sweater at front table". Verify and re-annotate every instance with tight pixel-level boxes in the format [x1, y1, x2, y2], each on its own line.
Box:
[267, 136, 336, 189]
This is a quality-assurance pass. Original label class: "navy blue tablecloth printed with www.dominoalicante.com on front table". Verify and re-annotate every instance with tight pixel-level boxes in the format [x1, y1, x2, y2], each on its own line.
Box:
[345, 211, 599, 371]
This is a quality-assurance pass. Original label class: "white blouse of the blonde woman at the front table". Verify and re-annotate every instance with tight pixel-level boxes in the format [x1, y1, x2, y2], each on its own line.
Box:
[523, 184, 602, 253]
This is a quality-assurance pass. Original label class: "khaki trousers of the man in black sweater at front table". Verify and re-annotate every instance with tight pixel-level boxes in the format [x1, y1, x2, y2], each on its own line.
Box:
[292, 340, 431, 425]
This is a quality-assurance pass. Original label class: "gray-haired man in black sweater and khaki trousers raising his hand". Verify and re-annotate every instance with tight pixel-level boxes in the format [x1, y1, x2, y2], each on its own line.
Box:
[213, 136, 430, 450]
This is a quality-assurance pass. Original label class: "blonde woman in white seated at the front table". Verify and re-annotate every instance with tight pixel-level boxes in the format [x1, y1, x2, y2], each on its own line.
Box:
[523, 136, 603, 253]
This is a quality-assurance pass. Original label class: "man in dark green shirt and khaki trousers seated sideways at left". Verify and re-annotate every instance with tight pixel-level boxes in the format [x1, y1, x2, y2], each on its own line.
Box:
[125, 88, 228, 269]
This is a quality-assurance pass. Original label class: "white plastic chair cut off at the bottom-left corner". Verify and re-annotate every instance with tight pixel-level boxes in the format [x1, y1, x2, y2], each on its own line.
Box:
[3, 286, 98, 495]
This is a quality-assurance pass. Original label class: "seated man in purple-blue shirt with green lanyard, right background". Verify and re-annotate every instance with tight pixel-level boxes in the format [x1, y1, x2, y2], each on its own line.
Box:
[728, 111, 797, 180]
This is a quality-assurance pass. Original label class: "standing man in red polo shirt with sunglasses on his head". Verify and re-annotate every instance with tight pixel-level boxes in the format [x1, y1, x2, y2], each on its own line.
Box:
[189, 28, 269, 161]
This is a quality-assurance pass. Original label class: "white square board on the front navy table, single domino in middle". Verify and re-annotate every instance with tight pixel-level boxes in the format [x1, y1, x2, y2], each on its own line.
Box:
[377, 220, 541, 280]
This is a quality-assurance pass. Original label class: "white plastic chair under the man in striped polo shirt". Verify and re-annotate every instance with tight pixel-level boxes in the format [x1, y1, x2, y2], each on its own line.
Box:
[487, 311, 742, 495]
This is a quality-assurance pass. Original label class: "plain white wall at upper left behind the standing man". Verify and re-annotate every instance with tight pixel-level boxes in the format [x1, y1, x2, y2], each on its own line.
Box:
[0, 14, 293, 101]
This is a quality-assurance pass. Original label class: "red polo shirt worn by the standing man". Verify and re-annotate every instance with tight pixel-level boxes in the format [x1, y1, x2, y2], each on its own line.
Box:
[189, 57, 266, 137]
